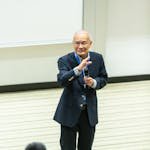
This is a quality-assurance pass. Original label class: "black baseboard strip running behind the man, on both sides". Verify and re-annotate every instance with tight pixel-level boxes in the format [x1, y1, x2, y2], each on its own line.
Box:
[0, 75, 150, 93]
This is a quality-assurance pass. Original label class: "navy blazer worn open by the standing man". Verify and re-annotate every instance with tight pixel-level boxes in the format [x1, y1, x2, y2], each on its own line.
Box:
[54, 52, 108, 127]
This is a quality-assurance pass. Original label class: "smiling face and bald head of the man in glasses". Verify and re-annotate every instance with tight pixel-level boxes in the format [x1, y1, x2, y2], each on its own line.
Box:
[73, 32, 92, 58]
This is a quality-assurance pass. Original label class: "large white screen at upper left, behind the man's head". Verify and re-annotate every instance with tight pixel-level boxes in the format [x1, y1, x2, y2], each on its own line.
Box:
[0, 0, 83, 47]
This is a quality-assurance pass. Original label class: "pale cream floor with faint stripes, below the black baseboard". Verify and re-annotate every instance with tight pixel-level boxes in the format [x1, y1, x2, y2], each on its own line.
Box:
[0, 81, 150, 150]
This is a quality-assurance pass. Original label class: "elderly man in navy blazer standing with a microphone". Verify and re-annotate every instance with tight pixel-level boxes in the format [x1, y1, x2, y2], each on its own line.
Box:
[54, 30, 107, 150]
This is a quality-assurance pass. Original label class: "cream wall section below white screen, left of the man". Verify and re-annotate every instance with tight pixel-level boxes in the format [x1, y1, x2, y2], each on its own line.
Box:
[0, 44, 72, 85]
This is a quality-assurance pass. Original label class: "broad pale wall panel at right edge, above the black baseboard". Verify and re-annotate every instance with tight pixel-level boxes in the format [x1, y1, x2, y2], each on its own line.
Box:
[105, 0, 150, 76]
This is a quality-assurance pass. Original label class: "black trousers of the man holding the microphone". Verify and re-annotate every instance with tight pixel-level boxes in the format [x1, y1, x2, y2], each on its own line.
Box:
[60, 110, 95, 150]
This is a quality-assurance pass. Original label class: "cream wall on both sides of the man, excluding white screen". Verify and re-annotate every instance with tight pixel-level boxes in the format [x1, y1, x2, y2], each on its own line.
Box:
[0, 0, 150, 86]
